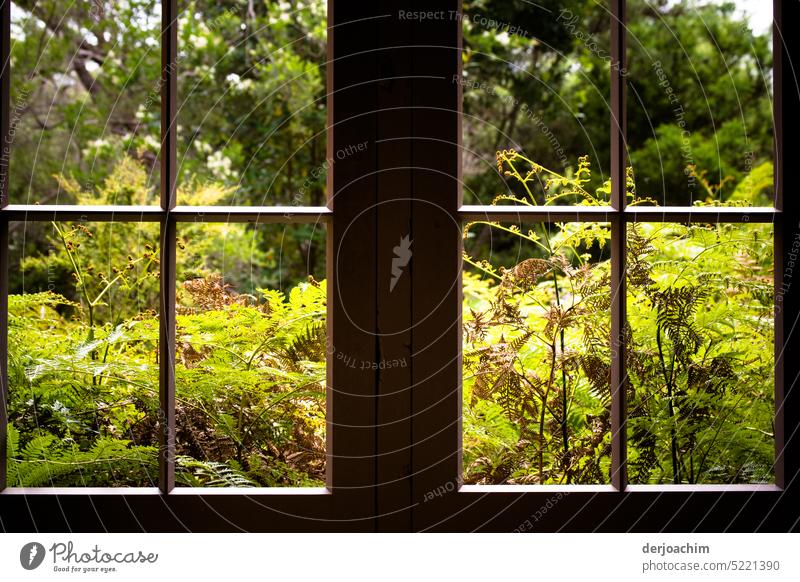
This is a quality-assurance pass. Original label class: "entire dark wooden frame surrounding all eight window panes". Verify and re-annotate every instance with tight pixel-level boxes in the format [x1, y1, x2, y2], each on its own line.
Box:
[0, 0, 800, 532]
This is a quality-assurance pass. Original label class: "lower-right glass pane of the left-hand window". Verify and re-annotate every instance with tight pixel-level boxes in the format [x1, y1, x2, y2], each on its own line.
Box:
[175, 224, 327, 487]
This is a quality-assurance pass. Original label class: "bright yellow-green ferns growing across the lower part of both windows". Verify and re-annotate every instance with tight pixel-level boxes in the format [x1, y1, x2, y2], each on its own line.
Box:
[8, 151, 774, 487]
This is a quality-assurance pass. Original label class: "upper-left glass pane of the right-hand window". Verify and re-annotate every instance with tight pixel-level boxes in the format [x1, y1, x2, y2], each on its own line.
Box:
[458, 0, 612, 205]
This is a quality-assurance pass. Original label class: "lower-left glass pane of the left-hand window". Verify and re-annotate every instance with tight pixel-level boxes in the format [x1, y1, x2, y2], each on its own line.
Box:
[8, 222, 159, 487]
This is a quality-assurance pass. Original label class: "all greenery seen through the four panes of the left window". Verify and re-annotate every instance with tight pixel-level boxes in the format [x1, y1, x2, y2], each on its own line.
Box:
[9, 0, 327, 486]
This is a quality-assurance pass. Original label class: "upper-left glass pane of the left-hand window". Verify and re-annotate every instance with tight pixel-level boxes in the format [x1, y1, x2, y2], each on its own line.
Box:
[3, 0, 161, 204]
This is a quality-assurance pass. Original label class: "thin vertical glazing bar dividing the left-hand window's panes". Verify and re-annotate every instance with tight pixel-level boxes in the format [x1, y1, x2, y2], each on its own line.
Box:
[158, 0, 178, 493]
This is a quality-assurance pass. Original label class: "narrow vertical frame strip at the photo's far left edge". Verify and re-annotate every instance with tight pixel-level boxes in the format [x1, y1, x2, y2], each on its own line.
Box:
[0, 0, 11, 491]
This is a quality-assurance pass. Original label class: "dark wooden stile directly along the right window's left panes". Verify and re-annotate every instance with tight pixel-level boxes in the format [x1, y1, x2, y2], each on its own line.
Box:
[409, 0, 462, 531]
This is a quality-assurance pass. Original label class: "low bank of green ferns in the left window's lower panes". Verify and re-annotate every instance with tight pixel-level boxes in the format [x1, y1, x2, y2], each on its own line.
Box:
[9, 270, 325, 487]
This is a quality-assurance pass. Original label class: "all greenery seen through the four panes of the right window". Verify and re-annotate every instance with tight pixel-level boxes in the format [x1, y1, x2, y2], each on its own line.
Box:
[462, 0, 774, 483]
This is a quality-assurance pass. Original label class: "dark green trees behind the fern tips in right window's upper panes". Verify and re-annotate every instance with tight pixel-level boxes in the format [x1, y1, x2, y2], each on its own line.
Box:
[463, 0, 774, 205]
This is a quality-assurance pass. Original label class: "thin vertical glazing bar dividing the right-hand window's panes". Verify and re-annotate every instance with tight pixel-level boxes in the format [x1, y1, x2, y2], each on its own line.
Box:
[610, 0, 627, 491]
